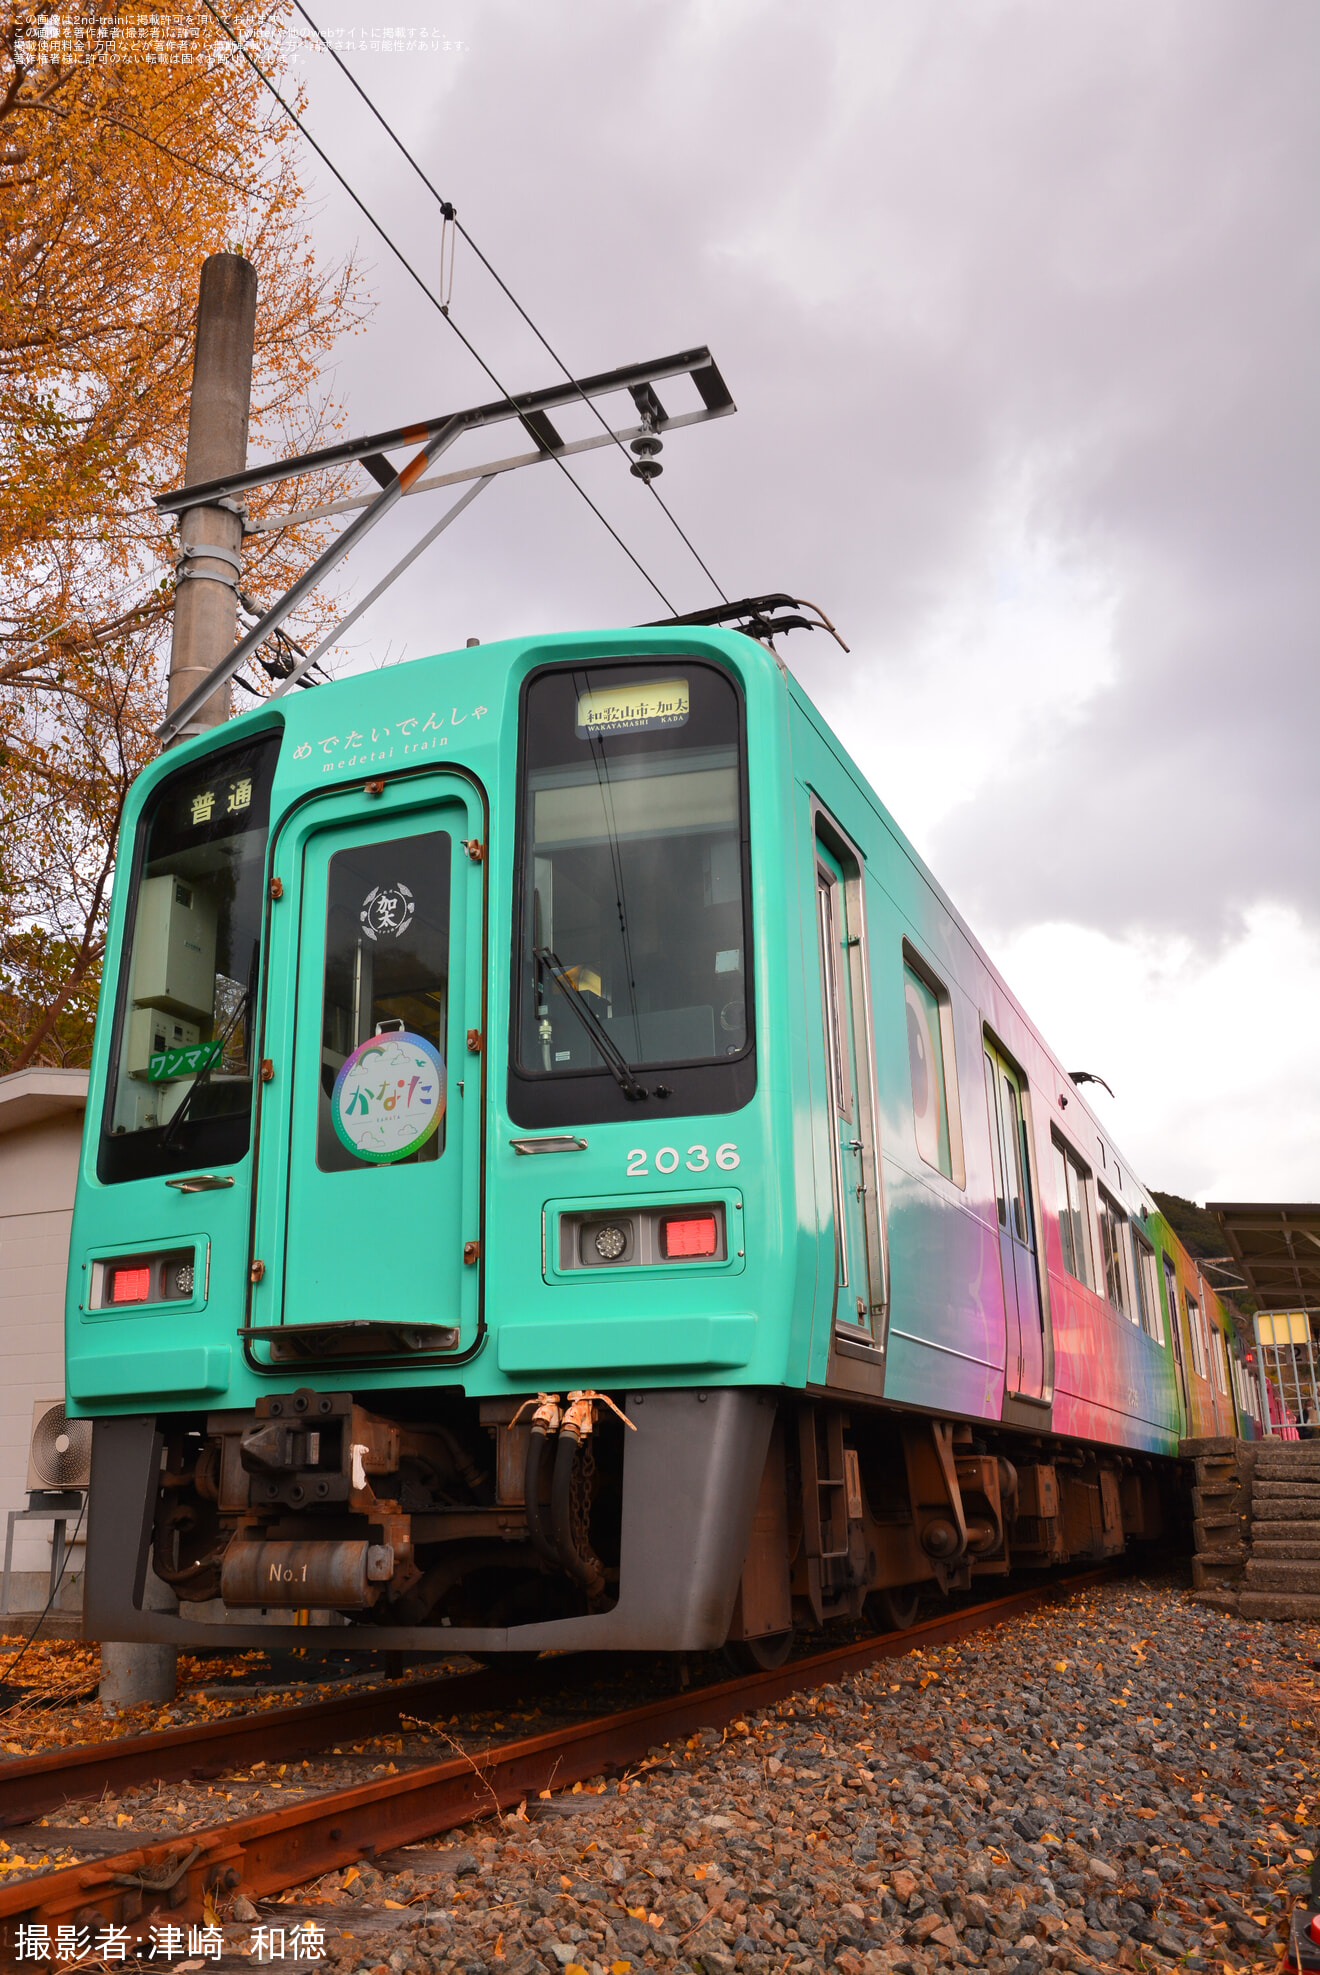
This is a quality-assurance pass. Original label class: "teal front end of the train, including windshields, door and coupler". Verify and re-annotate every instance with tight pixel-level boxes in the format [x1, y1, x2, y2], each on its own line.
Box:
[67, 632, 816, 1643]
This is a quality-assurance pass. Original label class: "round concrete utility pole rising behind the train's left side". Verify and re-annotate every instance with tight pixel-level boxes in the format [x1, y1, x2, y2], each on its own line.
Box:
[168, 253, 257, 741]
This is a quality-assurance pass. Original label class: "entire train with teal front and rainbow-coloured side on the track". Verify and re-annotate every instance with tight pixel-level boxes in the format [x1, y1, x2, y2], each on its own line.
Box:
[67, 626, 1251, 1651]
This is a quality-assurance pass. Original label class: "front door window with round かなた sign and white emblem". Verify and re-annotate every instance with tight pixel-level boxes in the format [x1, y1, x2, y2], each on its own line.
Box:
[316, 830, 453, 1173]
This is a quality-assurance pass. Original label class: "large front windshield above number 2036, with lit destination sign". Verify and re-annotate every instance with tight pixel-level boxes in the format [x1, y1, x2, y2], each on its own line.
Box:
[516, 660, 751, 1114]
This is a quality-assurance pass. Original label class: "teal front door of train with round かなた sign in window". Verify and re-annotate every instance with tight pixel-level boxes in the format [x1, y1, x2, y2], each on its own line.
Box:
[251, 776, 482, 1359]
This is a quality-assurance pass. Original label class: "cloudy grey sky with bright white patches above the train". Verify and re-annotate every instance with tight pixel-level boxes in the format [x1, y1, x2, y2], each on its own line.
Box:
[252, 0, 1320, 1199]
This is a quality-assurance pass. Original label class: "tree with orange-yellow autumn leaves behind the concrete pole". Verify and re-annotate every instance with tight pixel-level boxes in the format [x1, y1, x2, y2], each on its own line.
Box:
[0, 0, 366, 1072]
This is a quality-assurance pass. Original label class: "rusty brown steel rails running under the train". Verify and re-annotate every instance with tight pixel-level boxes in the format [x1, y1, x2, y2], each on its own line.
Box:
[0, 1564, 1126, 1957]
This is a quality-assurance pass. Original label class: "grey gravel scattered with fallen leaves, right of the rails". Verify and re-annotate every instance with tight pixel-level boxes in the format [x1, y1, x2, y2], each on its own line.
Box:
[211, 1582, 1320, 1975]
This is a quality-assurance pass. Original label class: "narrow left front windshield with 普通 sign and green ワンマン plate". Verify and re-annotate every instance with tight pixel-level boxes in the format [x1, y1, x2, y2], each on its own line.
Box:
[97, 735, 279, 1181]
